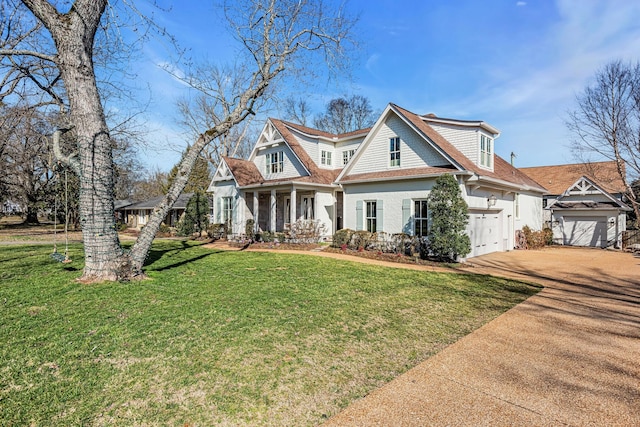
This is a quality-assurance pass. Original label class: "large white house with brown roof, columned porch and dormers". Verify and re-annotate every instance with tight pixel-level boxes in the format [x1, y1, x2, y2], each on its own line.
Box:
[208, 104, 546, 257]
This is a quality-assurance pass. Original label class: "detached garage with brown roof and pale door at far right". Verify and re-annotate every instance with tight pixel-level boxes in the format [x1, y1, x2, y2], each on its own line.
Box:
[520, 161, 632, 248]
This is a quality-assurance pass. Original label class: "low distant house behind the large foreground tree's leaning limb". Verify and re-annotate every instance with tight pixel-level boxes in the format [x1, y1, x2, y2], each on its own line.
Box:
[115, 193, 193, 230]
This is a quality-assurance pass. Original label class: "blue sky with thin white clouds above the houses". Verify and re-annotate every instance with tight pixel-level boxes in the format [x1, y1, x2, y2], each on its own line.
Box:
[131, 0, 640, 170]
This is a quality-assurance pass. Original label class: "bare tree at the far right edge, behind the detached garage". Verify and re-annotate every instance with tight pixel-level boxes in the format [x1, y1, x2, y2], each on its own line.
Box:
[567, 60, 640, 224]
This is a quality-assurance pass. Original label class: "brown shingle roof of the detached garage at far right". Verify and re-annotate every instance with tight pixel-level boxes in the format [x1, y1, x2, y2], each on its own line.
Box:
[520, 161, 625, 195]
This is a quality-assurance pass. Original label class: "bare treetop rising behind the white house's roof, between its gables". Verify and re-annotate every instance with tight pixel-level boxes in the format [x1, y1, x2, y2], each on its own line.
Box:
[314, 95, 376, 134]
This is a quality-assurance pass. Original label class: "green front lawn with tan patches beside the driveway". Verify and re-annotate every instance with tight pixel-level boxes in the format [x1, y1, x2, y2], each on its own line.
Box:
[0, 242, 538, 426]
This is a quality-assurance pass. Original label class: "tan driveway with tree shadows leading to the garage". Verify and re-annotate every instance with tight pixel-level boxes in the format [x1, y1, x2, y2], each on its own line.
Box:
[326, 248, 640, 426]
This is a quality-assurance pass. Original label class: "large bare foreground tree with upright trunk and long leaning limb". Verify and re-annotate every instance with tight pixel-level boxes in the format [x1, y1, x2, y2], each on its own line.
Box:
[0, 0, 353, 281]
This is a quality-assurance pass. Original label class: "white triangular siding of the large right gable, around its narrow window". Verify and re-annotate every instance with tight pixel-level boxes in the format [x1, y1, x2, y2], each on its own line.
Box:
[350, 116, 449, 174]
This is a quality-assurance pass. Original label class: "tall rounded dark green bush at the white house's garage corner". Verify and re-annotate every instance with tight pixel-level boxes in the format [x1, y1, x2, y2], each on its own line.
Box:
[428, 175, 471, 261]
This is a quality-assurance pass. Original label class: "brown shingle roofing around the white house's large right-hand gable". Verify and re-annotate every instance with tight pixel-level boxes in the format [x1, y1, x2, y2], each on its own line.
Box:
[338, 103, 545, 192]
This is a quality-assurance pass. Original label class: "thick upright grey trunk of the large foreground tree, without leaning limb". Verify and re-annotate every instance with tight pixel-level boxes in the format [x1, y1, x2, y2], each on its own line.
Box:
[43, 0, 132, 281]
